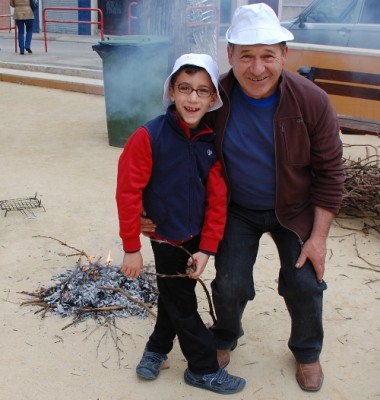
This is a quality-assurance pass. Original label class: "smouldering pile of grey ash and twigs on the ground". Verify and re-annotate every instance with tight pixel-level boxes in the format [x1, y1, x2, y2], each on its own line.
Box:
[22, 262, 158, 320]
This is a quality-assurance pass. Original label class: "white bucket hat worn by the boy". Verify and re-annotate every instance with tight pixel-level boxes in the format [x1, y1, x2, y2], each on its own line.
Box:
[163, 53, 223, 112]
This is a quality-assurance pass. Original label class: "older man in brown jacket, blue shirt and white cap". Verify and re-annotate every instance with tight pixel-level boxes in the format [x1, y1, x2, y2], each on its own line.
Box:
[206, 3, 344, 391]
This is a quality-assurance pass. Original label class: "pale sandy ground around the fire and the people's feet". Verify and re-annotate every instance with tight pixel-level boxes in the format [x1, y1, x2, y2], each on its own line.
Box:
[0, 82, 380, 400]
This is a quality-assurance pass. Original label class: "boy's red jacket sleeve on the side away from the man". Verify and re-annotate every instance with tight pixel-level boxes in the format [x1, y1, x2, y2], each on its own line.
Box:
[116, 127, 152, 252]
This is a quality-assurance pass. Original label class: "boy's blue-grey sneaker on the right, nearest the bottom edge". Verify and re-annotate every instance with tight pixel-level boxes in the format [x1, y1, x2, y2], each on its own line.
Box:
[184, 369, 245, 394]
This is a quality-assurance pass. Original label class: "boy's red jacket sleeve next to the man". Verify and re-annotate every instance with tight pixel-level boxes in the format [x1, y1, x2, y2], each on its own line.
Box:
[199, 161, 227, 254]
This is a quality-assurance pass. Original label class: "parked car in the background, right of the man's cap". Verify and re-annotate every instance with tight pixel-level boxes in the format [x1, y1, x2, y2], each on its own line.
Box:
[281, 0, 380, 49]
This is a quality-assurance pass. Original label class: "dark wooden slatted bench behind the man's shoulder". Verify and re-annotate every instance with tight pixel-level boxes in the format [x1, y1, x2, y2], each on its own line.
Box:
[298, 67, 380, 137]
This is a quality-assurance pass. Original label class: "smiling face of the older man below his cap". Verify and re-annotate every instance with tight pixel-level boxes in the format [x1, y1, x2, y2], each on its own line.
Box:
[227, 44, 288, 99]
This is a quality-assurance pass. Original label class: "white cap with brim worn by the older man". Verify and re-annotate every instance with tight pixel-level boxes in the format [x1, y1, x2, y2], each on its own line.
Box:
[226, 3, 294, 45]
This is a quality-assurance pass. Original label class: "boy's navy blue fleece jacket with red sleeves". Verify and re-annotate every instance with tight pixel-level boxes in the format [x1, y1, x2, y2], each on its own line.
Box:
[116, 106, 227, 254]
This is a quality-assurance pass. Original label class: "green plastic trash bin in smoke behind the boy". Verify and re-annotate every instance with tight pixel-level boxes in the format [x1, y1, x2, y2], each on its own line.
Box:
[92, 35, 170, 147]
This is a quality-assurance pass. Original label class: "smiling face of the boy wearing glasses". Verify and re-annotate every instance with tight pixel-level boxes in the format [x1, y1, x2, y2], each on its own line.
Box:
[169, 70, 216, 129]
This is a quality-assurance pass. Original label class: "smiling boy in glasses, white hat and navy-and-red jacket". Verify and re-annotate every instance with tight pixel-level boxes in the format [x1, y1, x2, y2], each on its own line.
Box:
[116, 54, 245, 394]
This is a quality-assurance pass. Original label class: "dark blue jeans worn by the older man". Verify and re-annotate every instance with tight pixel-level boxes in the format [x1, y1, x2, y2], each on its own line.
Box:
[211, 203, 327, 363]
